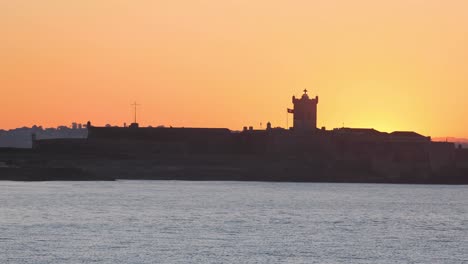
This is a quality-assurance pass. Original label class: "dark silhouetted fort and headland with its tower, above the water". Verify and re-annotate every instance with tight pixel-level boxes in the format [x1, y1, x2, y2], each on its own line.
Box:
[0, 90, 468, 184]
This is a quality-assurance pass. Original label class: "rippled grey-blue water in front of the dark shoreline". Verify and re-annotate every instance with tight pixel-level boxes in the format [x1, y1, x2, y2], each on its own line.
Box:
[0, 181, 468, 263]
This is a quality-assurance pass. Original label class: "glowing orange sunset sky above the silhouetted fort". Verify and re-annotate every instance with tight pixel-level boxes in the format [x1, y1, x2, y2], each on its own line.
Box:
[0, 0, 468, 137]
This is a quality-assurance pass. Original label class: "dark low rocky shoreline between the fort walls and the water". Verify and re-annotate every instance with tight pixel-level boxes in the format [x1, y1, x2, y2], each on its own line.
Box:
[0, 157, 468, 184]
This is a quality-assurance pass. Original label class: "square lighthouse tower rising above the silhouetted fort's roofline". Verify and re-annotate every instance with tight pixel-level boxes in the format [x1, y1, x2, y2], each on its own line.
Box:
[292, 89, 318, 131]
